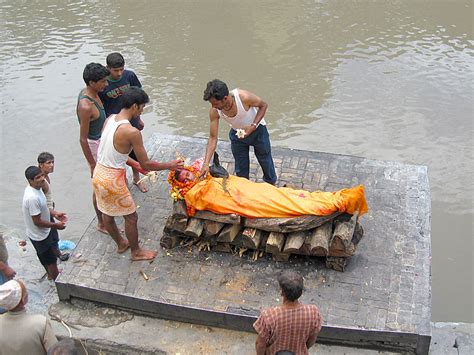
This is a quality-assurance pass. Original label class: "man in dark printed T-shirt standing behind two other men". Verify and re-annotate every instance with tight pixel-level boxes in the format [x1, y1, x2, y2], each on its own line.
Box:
[100, 53, 148, 192]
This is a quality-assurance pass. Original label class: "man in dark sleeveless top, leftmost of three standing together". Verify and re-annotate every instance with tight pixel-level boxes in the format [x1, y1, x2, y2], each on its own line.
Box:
[76, 63, 110, 234]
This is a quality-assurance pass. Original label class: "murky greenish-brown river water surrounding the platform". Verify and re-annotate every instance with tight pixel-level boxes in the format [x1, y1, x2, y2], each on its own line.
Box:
[0, 0, 474, 322]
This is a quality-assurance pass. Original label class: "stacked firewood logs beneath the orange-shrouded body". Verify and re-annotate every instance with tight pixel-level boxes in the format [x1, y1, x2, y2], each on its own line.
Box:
[160, 201, 364, 271]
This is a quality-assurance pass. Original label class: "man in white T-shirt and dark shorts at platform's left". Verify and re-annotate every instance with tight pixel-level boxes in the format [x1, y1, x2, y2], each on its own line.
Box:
[22, 166, 66, 280]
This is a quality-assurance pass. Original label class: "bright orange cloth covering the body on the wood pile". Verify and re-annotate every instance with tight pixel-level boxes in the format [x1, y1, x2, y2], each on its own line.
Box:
[184, 175, 368, 218]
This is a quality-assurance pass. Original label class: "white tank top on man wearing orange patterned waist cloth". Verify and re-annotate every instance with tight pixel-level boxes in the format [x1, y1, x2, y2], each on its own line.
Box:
[97, 115, 132, 169]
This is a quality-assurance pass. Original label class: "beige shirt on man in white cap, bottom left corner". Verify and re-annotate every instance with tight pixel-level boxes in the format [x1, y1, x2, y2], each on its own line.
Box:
[0, 310, 57, 355]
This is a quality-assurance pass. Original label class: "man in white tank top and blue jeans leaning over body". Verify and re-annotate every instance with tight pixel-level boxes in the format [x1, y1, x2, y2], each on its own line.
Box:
[201, 79, 277, 185]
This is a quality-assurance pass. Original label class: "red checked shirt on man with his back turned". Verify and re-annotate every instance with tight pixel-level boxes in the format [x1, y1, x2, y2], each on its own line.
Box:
[254, 303, 322, 354]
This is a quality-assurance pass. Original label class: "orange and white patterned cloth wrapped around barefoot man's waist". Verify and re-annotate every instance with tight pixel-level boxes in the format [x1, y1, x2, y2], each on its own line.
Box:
[92, 164, 136, 217]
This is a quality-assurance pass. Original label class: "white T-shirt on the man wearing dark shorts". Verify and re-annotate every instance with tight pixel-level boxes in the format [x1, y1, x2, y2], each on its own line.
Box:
[23, 185, 51, 241]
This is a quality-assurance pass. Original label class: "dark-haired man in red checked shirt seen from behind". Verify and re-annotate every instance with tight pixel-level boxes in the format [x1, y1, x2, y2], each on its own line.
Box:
[253, 271, 322, 355]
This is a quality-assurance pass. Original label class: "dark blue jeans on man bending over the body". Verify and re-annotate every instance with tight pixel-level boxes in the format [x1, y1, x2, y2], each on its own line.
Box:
[229, 125, 276, 185]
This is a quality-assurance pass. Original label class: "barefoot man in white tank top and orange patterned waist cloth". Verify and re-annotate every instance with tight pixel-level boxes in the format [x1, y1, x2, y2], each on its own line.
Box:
[92, 87, 183, 260]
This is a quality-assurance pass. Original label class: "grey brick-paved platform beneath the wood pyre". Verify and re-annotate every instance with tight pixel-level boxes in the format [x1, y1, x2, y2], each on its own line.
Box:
[56, 134, 431, 354]
